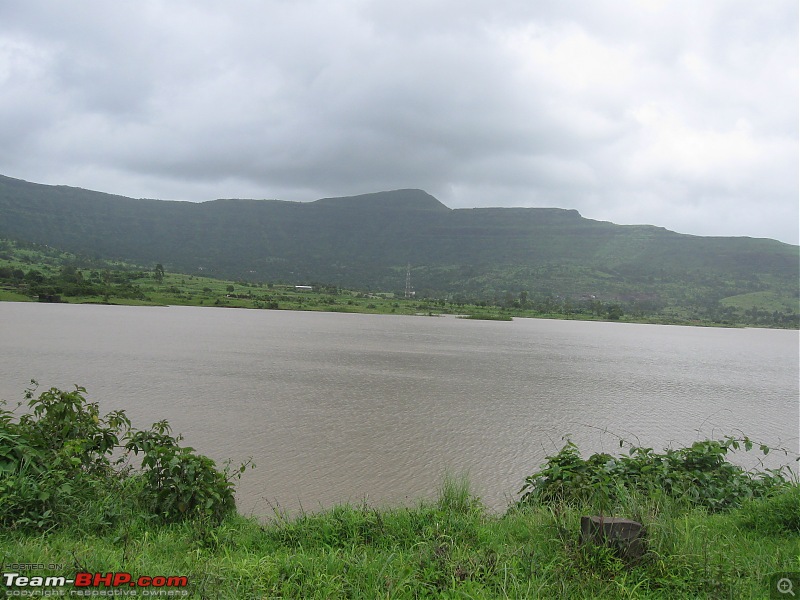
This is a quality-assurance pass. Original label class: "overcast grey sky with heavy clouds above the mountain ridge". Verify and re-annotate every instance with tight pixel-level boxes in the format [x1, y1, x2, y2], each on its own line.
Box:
[0, 0, 800, 244]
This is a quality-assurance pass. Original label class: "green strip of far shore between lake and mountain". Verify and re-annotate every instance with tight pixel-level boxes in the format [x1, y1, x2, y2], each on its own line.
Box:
[0, 240, 800, 328]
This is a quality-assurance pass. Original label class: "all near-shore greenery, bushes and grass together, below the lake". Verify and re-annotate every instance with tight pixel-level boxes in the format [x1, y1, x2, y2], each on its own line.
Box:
[0, 388, 800, 598]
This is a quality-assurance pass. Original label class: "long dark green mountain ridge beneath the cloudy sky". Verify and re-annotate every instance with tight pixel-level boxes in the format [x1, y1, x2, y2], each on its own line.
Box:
[0, 176, 800, 312]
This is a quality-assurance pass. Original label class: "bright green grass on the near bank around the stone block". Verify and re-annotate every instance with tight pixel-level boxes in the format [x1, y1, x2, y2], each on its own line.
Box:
[0, 477, 800, 598]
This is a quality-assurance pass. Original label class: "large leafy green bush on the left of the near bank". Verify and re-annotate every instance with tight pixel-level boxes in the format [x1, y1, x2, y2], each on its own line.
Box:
[0, 382, 246, 530]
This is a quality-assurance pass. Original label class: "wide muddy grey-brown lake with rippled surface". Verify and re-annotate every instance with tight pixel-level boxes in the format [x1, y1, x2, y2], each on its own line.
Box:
[0, 302, 800, 516]
